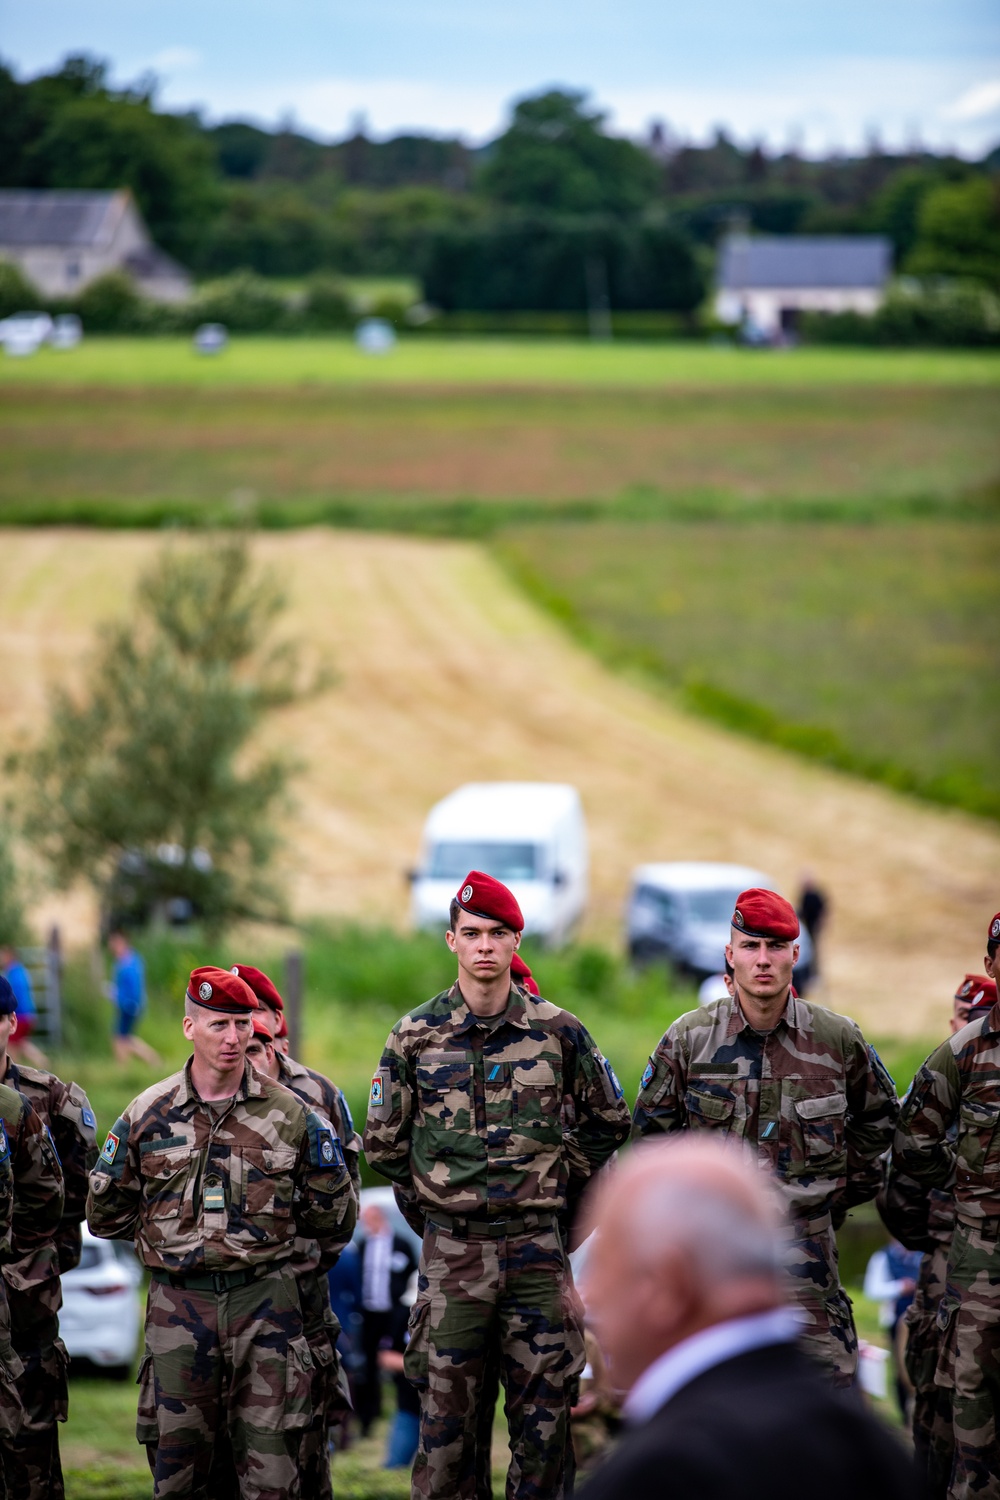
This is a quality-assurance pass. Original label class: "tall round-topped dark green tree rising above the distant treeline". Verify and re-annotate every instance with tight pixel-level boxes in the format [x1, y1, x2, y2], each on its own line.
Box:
[477, 89, 658, 215]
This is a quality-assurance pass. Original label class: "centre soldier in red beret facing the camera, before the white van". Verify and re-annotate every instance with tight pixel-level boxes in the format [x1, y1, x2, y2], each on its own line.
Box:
[364, 870, 628, 1500]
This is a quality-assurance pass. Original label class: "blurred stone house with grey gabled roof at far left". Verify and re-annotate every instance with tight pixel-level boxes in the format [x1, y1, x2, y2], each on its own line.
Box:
[0, 188, 190, 302]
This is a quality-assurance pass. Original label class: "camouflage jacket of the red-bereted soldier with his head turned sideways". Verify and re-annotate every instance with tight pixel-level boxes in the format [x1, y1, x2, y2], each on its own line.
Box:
[87, 1059, 355, 1275]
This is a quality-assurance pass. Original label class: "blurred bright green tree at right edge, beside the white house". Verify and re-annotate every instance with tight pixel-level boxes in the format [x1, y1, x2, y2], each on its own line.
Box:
[907, 177, 1000, 290]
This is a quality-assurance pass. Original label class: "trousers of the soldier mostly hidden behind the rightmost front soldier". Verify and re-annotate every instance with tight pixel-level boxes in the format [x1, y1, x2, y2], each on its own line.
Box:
[906, 1245, 955, 1500]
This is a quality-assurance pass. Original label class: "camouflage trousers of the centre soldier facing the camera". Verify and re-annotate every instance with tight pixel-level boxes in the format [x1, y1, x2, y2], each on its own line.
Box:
[405, 1218, 585, 1500]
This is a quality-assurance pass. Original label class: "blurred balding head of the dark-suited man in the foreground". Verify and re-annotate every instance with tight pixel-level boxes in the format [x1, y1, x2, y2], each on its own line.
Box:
[583, 1136, 783, 1389]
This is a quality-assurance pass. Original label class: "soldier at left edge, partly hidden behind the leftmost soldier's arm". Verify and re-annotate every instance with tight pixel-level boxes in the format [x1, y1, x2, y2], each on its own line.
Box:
[0, 981, 97, 1500]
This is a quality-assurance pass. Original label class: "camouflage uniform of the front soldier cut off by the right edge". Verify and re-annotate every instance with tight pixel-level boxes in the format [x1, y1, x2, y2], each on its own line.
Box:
[892, 1005, 1000, 1500]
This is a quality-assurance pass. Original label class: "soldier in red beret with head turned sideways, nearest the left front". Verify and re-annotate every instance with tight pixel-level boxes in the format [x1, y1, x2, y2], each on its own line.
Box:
[87, 968, 355, 1500]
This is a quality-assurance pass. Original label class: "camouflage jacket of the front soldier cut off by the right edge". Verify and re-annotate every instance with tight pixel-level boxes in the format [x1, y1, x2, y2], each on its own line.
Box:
[889, 1002, 1000, 1227]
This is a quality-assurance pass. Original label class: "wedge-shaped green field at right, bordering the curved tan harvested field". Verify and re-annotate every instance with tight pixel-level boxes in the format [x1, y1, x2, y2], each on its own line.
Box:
[502, 522, 1000, 816]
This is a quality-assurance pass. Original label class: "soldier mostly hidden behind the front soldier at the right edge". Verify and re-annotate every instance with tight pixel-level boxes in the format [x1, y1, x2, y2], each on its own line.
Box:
[879, 974, 997, 1500]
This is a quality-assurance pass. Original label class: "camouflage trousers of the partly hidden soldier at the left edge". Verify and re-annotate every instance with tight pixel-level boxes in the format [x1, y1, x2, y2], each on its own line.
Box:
[3, 1293, 69, 1500]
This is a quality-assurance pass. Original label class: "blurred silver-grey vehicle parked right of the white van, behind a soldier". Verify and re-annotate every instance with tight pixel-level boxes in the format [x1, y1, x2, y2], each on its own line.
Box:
[625, 861, 813, 995]
